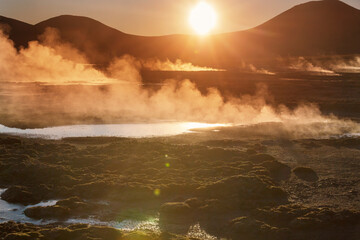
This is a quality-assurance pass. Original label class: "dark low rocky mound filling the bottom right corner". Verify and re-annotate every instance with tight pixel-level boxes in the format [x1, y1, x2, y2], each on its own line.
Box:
[254, 205, 360, 239]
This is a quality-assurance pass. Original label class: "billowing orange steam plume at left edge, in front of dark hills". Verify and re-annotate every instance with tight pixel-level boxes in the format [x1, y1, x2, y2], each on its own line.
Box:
[0, 29, 114, 84]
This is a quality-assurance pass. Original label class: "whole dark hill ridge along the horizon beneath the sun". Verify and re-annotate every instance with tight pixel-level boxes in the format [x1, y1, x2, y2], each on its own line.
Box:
[0, 0, 360, 67]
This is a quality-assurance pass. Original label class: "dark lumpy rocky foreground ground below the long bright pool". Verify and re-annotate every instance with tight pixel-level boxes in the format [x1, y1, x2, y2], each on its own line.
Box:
[0, 126, 360, 240]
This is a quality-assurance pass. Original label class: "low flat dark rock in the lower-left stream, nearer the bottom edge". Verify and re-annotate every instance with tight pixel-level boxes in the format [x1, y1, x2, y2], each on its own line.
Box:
[24, 205, 70, 219]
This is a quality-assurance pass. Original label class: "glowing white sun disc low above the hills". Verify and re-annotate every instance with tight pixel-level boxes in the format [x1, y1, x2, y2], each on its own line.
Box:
[189, 1, 217, 35]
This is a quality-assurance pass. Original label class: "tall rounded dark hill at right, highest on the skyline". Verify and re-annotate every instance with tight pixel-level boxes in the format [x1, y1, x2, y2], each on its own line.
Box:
[256, 0, 360, 55]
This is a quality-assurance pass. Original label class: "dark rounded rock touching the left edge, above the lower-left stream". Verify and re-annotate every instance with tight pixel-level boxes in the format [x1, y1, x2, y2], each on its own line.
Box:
[1, 186, 40, 205]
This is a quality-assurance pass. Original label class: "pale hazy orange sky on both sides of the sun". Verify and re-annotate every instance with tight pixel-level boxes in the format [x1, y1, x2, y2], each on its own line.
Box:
[0, 0, 360, 35]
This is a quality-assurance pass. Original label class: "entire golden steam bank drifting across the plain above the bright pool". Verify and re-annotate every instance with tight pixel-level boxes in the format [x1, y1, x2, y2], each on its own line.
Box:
[0, 28, 360, 137]
